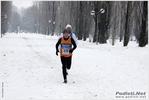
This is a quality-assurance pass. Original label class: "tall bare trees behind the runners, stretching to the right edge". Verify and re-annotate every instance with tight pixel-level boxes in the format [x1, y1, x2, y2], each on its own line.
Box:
[4, 1, 148, 47]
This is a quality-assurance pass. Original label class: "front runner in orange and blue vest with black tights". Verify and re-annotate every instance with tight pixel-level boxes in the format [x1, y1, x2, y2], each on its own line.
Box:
[56, 29, 77, 83]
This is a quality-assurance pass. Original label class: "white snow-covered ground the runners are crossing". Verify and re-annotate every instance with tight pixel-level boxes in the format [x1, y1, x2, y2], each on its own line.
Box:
[0, 33, 149, 99]
